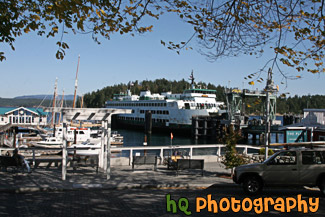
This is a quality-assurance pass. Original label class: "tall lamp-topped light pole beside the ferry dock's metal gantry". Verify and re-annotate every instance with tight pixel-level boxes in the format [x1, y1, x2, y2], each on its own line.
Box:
[264, 68, 278, 160]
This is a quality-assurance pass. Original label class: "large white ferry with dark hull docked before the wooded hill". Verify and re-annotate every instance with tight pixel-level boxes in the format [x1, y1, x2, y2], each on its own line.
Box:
[105, 72, 224, 132]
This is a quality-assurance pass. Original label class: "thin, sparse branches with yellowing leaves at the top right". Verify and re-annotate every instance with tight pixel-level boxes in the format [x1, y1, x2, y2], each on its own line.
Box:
[162, 0, 325, 78]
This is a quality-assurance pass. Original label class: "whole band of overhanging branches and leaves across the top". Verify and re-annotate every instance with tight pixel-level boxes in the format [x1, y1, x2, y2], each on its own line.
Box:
[0, 0, 325, 78]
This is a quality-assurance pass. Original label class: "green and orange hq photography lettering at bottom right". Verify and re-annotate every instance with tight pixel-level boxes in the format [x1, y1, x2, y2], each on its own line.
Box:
[166, 194, 319, 215]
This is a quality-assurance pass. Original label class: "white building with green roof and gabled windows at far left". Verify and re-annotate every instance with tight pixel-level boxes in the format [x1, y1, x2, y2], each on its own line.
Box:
[0, 107, 47, 126]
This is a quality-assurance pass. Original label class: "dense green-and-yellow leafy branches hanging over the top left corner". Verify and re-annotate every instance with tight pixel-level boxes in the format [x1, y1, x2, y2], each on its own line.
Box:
[0, 0, 159, 61]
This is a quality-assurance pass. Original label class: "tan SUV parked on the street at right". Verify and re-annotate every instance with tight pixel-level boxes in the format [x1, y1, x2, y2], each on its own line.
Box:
[233, 148, 325, 195]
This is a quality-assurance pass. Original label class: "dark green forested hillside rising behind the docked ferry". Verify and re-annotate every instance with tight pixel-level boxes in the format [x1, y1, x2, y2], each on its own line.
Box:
[84, 79, 325, 114]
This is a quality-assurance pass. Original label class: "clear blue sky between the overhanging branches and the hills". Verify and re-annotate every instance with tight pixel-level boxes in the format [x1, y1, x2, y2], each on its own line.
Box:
[0, 15, 325, 98]
